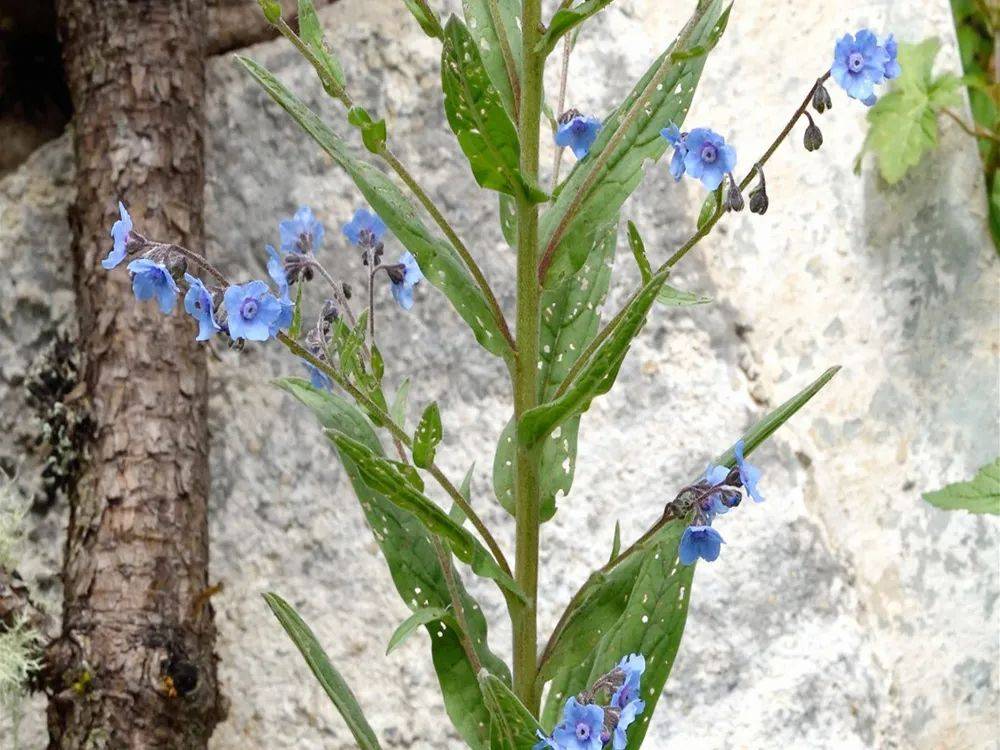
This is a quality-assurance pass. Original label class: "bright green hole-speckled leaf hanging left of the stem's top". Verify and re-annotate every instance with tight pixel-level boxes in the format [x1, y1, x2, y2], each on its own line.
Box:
[441, 16, 527, 196]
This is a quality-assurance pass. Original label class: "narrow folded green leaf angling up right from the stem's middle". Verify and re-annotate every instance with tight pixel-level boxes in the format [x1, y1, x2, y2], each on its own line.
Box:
[517, 269, 669, 445]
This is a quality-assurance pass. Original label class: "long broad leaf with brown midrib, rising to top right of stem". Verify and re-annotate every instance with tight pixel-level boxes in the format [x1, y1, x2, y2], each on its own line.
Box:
[540, 0, 729, 286]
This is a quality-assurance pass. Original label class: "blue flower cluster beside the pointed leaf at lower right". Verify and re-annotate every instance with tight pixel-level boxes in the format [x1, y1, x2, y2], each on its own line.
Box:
[679, 440, 764, 565]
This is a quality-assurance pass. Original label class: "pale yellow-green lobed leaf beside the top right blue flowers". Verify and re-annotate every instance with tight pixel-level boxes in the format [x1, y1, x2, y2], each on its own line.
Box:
[863, 38, 961, 185]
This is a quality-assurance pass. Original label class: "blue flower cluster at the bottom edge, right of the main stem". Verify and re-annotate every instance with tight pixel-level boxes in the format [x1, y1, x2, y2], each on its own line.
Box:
[533, 654, 646, 750]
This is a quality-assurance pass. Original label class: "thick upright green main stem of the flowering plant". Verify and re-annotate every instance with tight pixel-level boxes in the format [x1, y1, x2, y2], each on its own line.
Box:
[511, 0, 545, 713]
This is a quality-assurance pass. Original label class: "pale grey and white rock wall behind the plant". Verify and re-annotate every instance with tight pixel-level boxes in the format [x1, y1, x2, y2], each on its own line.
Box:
[0, 0, 1000, 750]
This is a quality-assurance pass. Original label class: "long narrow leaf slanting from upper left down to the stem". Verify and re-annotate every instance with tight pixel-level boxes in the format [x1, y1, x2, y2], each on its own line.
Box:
[236, 55, 511, 357]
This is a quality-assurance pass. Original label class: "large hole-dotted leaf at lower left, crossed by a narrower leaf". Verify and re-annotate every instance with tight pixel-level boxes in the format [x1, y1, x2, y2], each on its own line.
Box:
[277, 378, 510, 749]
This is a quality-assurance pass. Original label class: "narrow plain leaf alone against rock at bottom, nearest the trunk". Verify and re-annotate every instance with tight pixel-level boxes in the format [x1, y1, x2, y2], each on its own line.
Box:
[264, 593, 381, 750]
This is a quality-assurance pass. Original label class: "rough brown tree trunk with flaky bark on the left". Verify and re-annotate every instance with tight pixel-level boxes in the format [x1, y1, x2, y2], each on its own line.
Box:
[48, 0, 223, 750]
